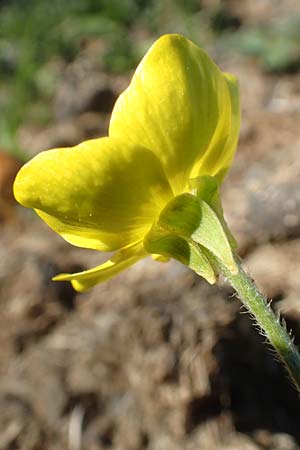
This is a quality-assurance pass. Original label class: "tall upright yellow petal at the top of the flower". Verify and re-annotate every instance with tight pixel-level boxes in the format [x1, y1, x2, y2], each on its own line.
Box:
[109, 35, 240, 194]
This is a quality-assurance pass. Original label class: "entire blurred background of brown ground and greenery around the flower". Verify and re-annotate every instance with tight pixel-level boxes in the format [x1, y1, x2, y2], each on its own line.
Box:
[0, 0, 300, 450]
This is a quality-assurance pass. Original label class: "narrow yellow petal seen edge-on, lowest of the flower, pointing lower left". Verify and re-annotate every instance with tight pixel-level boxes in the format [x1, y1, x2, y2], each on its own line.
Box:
[52, 242, 147, 292]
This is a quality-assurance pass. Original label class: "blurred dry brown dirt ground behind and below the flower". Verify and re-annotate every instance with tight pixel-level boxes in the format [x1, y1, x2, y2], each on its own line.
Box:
[0, 6, 300, 450]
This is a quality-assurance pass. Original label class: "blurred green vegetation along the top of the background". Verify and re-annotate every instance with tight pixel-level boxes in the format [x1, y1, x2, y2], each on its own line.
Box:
[0, 0, 300, 153]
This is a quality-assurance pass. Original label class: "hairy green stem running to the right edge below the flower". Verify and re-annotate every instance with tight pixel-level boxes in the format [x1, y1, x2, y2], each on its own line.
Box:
[215, 260, 300, 393]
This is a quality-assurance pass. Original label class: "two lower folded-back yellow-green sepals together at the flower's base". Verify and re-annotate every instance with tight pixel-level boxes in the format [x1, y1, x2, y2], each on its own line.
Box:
[144, 193, 238, 284]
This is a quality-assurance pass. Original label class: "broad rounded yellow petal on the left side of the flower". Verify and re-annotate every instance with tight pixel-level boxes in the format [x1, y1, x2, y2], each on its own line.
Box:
[14, 138, 172, 251]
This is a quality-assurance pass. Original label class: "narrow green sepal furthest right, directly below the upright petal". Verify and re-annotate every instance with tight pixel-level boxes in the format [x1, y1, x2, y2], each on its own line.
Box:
[189, 175, 237, 250]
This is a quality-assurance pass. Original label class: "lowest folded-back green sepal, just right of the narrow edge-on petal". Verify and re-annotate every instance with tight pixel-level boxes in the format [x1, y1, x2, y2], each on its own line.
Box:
[144, 224, 216, 284]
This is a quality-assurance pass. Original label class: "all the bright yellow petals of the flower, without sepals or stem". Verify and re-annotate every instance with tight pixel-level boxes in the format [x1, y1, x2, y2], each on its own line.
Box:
[14, 34, 239, 291]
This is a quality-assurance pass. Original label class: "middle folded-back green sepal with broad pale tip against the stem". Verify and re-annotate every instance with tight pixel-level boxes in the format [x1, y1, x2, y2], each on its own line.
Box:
[156, 194, 238, 274]
